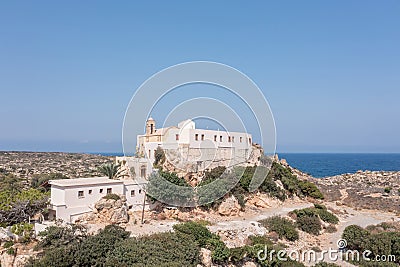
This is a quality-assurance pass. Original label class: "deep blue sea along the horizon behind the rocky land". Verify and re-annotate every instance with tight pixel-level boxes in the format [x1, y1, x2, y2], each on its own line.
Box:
[94, 153, 400, 178]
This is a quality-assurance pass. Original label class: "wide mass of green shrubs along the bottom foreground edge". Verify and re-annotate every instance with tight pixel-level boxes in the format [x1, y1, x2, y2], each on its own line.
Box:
[27, 222, 304, 267]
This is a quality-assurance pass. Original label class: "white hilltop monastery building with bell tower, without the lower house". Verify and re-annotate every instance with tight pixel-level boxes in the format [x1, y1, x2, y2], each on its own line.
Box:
[136, 118, 252, 170]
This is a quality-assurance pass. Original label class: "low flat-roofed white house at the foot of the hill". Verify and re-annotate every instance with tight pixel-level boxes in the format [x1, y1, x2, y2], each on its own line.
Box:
[49, 177, 148, 222]
